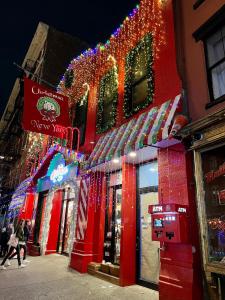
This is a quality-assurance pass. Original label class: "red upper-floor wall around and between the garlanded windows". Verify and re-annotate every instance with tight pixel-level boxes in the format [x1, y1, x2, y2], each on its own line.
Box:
[62, 0, 181, 153]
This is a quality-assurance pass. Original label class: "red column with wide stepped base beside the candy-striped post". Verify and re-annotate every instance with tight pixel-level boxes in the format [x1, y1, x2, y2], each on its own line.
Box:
[70, 172, 106, 273]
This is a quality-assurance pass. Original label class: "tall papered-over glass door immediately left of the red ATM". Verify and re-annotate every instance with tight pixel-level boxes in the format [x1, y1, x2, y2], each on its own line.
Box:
[137, 161, 160, 290]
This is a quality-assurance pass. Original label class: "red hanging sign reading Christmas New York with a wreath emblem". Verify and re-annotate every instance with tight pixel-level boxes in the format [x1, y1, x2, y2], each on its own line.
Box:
[22, 78, 71, 138]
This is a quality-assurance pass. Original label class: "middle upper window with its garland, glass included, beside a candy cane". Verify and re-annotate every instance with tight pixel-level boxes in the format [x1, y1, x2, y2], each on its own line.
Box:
[96, 66, 118, 133]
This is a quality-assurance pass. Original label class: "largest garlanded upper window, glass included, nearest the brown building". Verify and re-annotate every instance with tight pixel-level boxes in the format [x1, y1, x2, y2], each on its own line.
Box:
[123, 34, 154, 118]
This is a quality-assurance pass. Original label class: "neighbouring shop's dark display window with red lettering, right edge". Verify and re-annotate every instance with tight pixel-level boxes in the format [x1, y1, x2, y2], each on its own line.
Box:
[202, 146, 225, 266]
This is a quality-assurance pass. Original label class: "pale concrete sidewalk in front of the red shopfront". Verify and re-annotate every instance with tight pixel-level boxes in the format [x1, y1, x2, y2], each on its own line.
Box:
[0, 254, 158, 300]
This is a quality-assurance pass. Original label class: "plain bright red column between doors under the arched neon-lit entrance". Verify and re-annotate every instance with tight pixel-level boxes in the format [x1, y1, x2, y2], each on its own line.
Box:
[45, 190, 63, 254]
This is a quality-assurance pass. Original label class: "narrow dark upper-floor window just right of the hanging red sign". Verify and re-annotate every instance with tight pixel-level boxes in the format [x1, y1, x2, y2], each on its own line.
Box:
[73, 93, 88, 149]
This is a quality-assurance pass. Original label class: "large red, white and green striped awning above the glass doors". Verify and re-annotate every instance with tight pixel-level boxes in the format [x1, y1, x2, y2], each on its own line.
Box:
[88, 95, 181, 167]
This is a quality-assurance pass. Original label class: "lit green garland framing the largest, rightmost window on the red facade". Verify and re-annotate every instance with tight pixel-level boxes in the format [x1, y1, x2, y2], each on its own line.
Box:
[123, 33, 154, 118]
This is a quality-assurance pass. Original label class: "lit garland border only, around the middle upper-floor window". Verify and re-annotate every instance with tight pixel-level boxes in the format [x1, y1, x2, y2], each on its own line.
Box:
[96, 66, 118, 134]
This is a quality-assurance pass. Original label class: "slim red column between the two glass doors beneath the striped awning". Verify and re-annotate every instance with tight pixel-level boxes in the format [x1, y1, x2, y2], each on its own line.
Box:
[120, 161, 136, 286]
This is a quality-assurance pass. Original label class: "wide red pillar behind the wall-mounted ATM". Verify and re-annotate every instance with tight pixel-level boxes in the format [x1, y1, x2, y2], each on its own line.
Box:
[158, 144, 202, 300]
